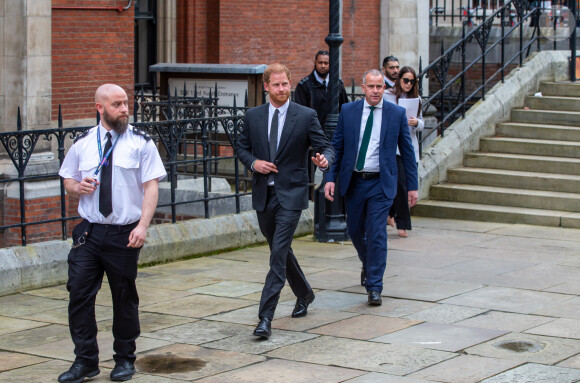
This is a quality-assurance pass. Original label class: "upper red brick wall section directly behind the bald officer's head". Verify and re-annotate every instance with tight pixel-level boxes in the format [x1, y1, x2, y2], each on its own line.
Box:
[52, 0, 135, 120]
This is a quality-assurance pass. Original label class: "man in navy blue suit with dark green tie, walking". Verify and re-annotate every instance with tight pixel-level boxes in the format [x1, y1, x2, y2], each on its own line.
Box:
[324, 69, 418, 306]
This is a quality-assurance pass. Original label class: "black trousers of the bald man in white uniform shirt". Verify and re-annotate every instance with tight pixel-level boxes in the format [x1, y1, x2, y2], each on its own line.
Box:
[66, 220, 141, 364]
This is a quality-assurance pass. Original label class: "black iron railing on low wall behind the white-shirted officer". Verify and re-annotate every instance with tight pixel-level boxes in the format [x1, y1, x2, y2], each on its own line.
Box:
[0, 92, 251, 245]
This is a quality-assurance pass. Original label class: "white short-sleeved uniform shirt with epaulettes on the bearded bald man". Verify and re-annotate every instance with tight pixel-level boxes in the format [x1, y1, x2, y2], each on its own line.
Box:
[58, 125, 167, 225]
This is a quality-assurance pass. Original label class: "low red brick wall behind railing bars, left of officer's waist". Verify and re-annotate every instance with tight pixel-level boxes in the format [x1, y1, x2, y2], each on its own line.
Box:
[0, 195, 80, 247]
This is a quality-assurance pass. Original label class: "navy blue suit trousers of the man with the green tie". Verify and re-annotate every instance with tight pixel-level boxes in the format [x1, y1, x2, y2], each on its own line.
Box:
[345, 176, 393, 292]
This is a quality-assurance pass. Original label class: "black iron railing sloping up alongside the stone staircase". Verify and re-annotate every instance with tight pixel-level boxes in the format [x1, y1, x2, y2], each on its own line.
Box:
[418, 0, 578, 153]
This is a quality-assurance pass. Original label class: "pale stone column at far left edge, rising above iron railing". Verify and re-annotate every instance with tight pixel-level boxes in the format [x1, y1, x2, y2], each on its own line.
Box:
[0, 0, 52, 135]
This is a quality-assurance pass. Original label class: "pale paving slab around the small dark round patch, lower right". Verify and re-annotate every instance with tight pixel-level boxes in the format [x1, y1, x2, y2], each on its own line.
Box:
[465, 333, 580, 364]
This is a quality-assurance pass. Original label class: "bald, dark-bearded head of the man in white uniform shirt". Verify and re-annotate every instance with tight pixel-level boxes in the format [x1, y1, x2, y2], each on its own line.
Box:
[95, 84, 129, 134]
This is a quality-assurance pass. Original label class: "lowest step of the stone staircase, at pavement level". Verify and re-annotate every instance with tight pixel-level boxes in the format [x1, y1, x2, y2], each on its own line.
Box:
[411, 200, 580, 229]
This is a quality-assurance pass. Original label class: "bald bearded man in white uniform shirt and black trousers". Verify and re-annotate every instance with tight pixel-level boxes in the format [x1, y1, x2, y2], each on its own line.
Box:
[58, 84, 167, 383]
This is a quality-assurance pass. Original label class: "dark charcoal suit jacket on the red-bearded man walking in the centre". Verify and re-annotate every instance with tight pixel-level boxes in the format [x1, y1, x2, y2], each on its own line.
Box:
[237, 102, 334, 211]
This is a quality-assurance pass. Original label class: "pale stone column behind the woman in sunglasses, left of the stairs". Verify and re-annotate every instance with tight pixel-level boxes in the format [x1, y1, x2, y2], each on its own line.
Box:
[379, 0, 429, 76]
